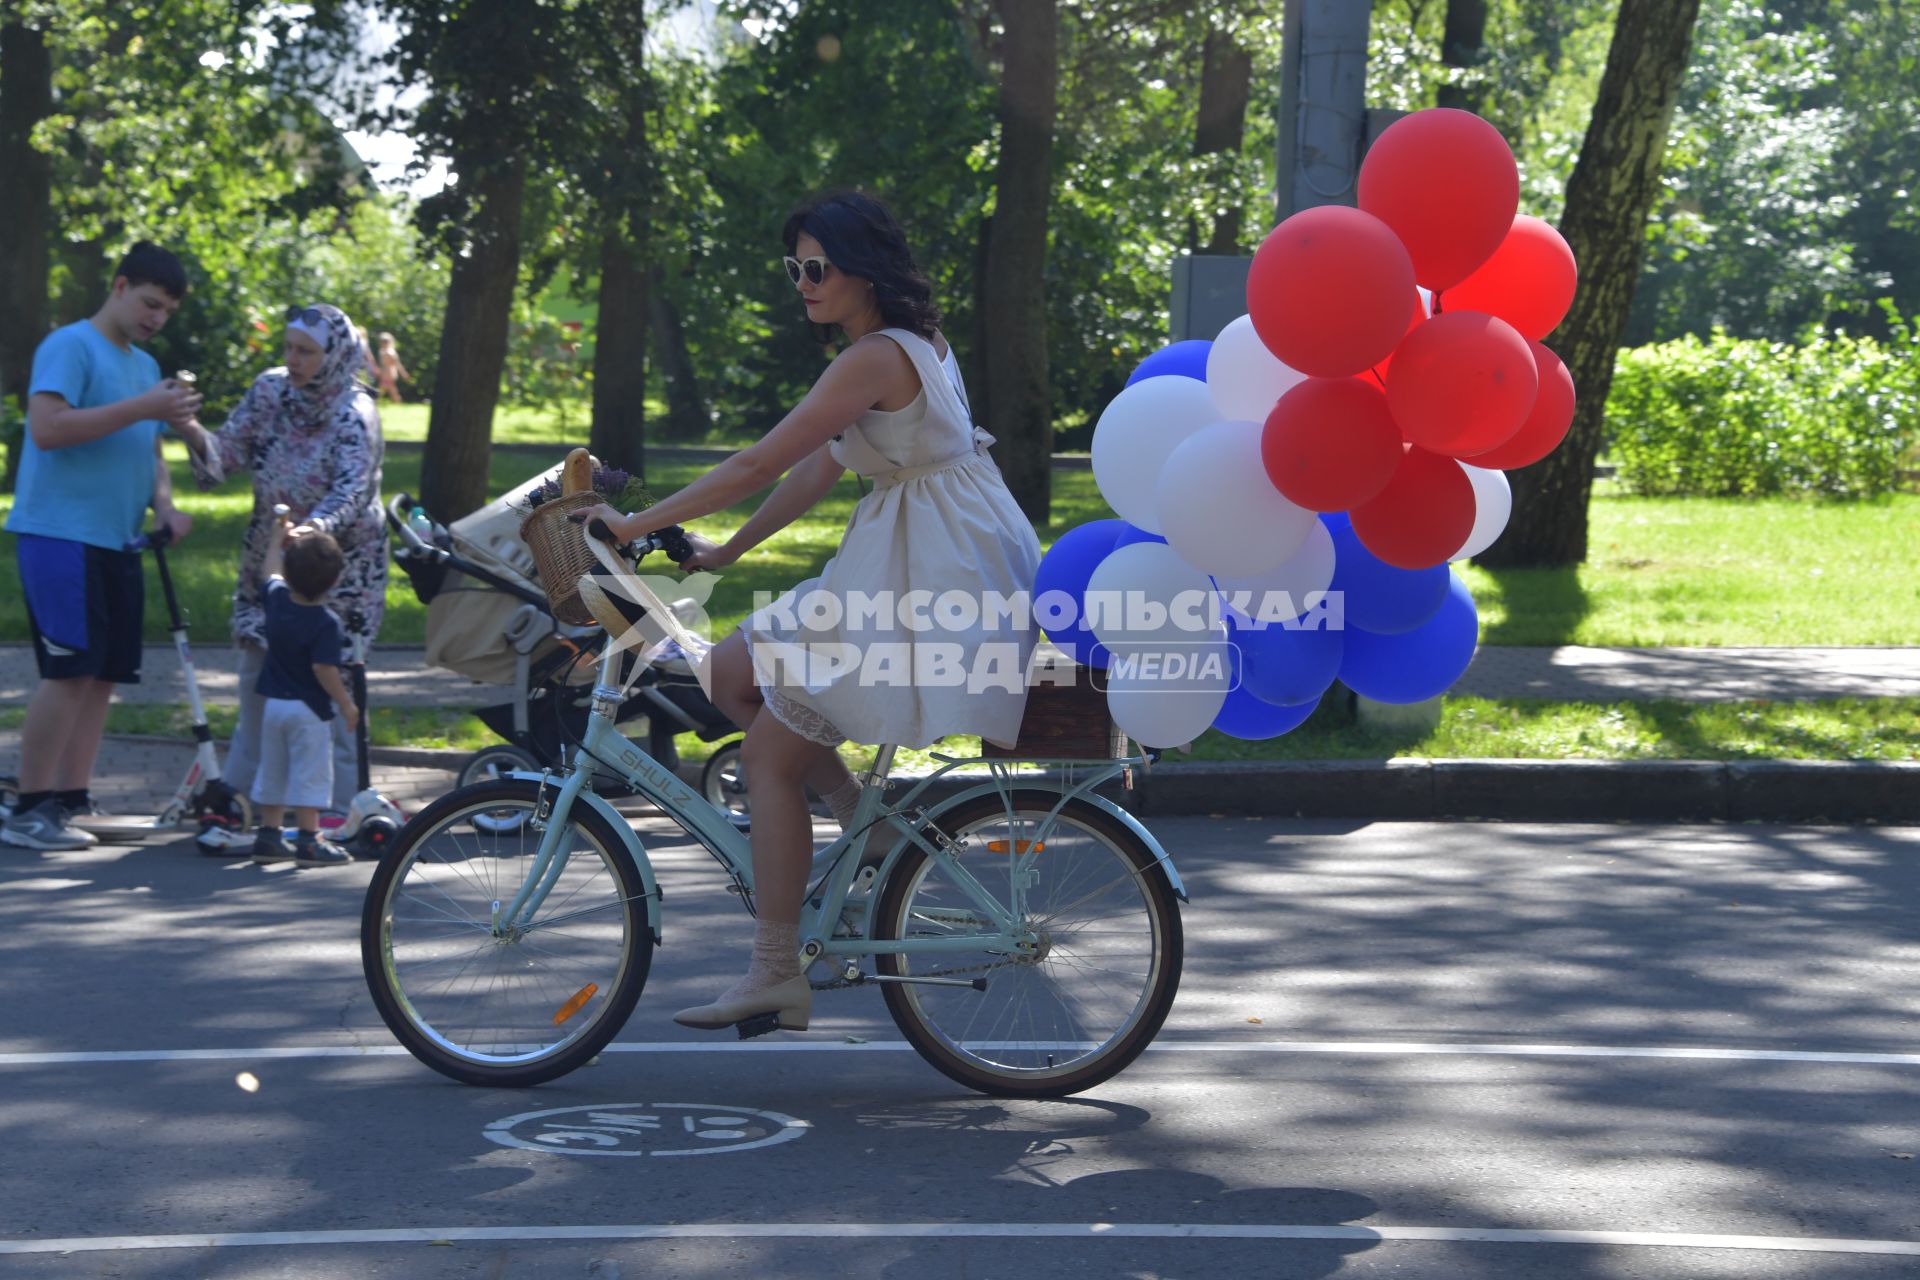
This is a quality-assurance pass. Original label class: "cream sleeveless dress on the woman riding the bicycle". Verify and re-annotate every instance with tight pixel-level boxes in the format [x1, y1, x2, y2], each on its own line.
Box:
[741, 328, 1041, 747]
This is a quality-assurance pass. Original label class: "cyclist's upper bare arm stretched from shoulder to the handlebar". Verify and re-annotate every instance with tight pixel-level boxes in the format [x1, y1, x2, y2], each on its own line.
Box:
[580, 338, 912, 541]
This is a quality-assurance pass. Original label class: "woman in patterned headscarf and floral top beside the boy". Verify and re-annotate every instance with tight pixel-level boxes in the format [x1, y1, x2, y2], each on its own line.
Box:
[194, 303, 386, 812]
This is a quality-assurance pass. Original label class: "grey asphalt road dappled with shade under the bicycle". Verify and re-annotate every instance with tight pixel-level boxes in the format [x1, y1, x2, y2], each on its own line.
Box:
[0, 819, 1920, 1280]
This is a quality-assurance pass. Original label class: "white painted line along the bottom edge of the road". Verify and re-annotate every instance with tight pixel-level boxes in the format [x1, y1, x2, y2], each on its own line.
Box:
[0, 1222, 1920, 1257]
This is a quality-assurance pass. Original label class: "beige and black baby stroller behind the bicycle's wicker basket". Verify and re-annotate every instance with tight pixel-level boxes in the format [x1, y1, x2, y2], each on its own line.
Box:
[386, 468, 747, 816]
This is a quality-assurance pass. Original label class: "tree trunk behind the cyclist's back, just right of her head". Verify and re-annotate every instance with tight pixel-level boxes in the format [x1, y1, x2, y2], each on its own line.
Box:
[987, 0, 1060, 524]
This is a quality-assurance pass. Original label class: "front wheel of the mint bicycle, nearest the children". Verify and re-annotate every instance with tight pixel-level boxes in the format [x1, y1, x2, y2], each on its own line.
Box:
[361, 777, 653, 1088]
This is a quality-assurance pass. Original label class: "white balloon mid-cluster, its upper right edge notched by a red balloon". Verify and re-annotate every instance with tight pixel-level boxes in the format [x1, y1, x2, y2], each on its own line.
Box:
[1154, 422, 1319, 574]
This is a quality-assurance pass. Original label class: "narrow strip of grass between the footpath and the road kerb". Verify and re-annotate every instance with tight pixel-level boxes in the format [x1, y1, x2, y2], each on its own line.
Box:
[0, 699, 1920, 771]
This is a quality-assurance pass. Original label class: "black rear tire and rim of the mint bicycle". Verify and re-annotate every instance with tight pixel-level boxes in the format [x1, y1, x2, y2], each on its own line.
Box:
[874, 787, 1183, 1098]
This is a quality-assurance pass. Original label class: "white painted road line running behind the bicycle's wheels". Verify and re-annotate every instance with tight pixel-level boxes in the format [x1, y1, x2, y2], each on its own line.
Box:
[0, 1040, 1920, 1067]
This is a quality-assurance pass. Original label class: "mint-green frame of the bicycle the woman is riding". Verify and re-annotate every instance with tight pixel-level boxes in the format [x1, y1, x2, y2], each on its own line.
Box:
[493, 649, 1187, 961]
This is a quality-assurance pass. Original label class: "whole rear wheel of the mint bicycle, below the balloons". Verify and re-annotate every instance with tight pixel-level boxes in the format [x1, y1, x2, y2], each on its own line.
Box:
[874, 789, 1181, 1098]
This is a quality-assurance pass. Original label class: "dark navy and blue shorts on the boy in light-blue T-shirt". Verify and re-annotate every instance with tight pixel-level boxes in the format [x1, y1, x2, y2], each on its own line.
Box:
[13, 533, 146, 685]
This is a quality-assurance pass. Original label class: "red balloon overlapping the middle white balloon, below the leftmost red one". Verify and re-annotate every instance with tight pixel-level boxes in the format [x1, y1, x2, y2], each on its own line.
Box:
[1260, 378, 1402, 510]
